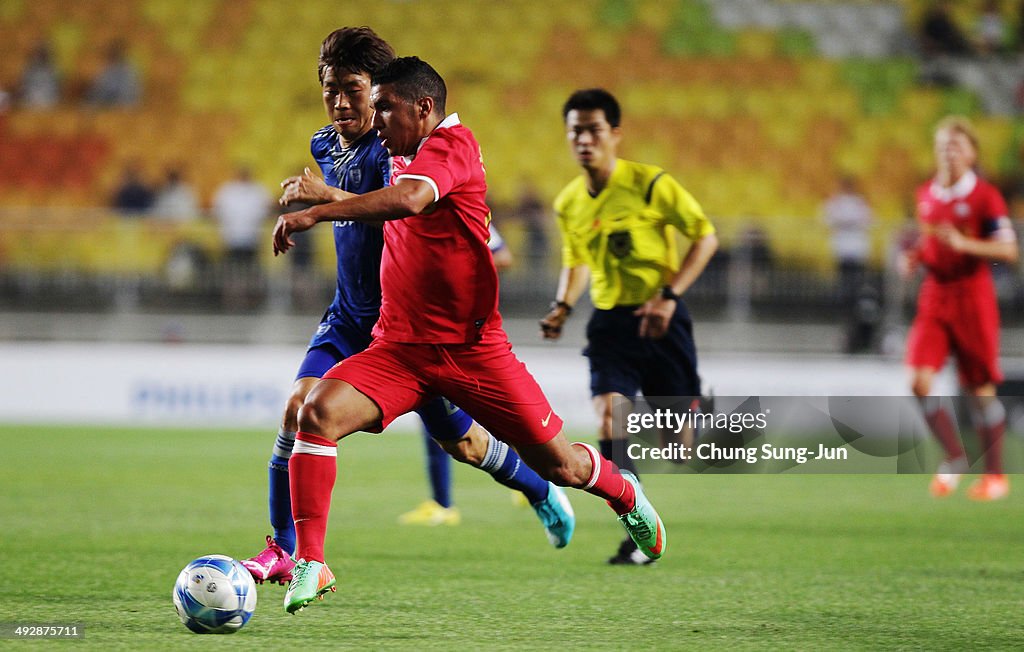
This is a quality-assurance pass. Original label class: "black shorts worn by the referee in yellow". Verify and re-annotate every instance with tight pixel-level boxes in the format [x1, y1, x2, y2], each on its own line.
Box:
[583, 301, 700, 398]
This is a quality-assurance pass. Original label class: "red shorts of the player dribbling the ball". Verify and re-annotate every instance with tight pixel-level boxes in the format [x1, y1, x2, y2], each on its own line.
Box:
[324, 331, 562, 446]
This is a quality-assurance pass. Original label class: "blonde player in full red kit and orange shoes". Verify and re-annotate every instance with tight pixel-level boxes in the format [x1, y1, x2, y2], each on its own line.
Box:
[902, 117, 1019, 501]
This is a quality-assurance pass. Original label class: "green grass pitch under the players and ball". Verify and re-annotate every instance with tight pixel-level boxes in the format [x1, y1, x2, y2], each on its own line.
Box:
[0, 426, 1024, 650]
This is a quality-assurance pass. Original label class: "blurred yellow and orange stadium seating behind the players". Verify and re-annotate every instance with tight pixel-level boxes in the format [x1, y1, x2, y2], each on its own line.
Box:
[0, 0, 1024, 270]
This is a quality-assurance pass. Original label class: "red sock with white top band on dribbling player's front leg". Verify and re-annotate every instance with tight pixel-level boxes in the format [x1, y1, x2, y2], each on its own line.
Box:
[288, 432, 338, 562]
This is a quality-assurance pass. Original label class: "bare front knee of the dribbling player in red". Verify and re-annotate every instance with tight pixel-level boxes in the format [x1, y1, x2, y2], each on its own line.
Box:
[298, 378, 384, 441]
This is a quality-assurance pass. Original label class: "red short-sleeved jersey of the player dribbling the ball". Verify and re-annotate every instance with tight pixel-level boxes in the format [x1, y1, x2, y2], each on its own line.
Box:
[373, 114, 501, 344]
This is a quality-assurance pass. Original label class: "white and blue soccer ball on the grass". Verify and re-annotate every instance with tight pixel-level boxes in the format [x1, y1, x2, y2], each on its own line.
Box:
[171, 555, 256, 634]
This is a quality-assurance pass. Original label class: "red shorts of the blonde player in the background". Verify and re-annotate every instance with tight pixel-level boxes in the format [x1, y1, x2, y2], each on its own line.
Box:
[906, 277, 1002, 387]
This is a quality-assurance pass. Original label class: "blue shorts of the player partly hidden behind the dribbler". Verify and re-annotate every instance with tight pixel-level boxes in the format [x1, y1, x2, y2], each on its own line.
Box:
[295, 312, 473, 441]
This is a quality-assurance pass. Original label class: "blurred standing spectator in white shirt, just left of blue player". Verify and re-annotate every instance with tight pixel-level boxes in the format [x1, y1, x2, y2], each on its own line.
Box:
[213, 167, 276, 310]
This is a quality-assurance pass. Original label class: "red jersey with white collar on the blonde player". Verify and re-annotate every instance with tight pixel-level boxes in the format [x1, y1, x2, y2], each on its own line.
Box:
[918, 171, 1015, 284]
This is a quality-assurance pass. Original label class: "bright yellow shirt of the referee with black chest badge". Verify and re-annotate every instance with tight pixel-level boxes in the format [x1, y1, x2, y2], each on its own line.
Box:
[555, 159, 715, 310]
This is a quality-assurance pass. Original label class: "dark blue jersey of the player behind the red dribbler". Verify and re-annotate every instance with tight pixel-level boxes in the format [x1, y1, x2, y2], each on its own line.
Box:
[309, 125, 391, 336]
